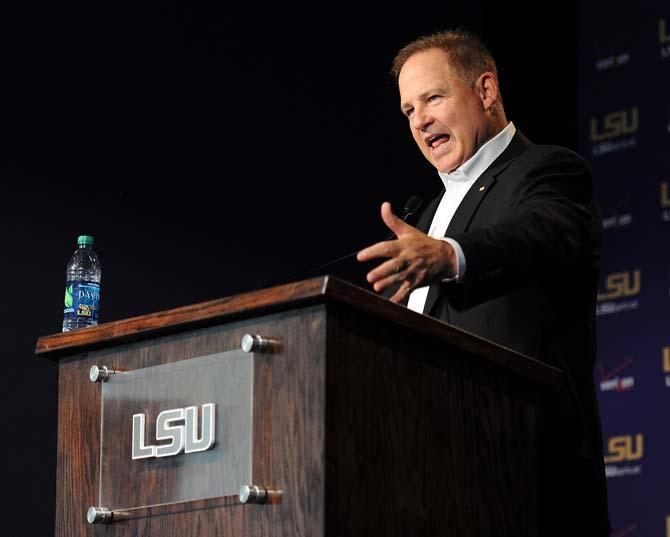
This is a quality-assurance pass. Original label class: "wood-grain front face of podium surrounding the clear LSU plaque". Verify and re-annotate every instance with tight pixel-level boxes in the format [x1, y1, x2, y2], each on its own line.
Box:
[56, 306, 326, 537]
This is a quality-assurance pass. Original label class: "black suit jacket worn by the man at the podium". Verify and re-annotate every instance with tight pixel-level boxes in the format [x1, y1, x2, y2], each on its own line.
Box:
[417, 132, 609, 535]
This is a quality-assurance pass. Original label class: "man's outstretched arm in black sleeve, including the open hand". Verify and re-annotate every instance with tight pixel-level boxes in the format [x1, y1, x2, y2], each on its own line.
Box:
[358, 149, 599, 302]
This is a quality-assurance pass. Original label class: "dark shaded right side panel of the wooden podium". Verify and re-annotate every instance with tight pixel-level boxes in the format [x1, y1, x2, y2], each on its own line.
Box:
[326, 307, 542, 537]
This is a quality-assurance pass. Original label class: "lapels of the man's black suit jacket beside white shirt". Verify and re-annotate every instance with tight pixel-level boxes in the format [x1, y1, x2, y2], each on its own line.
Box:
[423, 131, 530, 315]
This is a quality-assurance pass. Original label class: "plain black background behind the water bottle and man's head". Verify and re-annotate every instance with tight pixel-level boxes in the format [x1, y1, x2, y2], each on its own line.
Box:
[0, 0, 577, 535]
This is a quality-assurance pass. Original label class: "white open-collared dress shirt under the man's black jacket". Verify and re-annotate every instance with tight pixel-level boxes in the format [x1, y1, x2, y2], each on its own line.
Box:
[407, 123, 516, 313]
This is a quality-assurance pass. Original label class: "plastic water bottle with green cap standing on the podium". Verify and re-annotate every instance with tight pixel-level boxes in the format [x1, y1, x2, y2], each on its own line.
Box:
[63, 235, 102, 332]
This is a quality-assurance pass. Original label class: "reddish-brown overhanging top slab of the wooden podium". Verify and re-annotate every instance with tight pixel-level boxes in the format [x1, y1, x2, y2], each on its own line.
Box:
[35, 276, 563, 387]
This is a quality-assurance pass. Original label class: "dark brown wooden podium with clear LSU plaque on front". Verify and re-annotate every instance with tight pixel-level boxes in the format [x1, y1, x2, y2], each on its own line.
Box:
[37, 277, 563, 537]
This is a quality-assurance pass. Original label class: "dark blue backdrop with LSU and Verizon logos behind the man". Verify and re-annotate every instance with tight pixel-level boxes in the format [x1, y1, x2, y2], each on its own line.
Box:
[578, 0, 670, 537]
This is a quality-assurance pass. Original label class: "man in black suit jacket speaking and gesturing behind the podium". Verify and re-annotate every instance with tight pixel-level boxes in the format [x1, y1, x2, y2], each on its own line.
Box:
[358, 31, 610, 536]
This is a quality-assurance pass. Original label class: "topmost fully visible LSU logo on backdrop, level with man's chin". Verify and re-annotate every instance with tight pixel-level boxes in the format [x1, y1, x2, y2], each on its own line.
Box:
[589, 106, 640, 157]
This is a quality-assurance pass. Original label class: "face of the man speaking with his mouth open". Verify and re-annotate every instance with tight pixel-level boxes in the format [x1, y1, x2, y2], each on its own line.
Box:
[398, 49, 490, 172]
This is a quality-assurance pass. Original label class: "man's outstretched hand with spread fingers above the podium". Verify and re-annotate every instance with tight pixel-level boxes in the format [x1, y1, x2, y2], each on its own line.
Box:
[356, 202, 456, 302]
